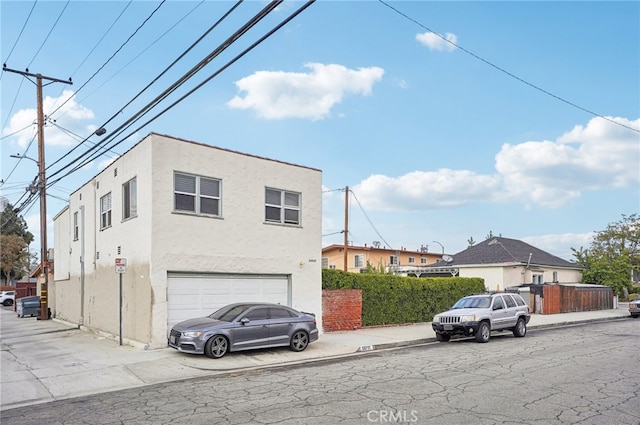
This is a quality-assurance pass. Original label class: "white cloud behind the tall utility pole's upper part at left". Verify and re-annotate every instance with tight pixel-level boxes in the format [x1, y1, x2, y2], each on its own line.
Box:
[2, 90, 95, 149]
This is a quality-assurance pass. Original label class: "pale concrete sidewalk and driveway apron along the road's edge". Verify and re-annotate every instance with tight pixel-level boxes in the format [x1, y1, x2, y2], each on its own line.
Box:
[0, 304, 632, 410]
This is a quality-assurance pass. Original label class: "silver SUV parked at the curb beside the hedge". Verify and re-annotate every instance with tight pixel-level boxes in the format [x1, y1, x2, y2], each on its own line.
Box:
[431, 292, 531, 342]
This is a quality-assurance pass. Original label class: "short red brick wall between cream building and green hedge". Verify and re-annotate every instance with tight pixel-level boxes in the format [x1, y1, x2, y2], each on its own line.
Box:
[322, 289, 362, 332]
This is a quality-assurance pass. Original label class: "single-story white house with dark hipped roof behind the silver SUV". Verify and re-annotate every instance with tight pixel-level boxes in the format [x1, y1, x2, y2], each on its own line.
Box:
[425, 237, 584, 290]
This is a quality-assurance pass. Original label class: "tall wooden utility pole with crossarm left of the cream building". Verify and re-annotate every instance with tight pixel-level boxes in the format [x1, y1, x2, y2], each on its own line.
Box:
[3, 65, 73, 320]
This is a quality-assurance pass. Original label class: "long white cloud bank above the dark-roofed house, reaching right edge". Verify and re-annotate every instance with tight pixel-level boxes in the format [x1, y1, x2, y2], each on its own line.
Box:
[353, 118, 640, 211]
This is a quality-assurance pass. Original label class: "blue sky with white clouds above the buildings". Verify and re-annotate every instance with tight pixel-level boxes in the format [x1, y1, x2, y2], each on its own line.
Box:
[0, 0, 640, 260]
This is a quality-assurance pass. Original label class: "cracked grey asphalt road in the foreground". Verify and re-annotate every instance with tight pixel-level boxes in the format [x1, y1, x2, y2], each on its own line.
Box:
[0, 319, 640, 425]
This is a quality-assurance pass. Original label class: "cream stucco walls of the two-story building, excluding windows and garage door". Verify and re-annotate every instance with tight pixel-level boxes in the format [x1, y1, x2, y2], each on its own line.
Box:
[54, 134, 322, 347]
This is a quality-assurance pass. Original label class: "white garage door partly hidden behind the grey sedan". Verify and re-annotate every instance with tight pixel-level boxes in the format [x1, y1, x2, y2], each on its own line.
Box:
[167, 273, 290, 332]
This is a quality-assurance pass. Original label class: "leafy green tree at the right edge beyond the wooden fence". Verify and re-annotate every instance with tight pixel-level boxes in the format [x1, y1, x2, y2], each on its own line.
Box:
[571, 214, 640, 297]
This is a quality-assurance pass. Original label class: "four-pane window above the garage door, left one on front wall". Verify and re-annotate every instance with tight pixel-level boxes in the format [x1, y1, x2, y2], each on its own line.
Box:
[174, 173, 221, 216]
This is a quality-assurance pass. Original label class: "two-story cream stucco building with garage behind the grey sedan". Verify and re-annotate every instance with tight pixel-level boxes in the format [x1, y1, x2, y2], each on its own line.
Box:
[49, 133, 322, 348]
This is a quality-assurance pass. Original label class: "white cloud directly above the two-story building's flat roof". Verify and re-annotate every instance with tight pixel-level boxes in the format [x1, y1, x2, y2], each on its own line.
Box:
[227, 63, 384, 120]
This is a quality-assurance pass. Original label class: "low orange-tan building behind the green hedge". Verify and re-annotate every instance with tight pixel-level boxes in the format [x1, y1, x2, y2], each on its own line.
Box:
[322, 244, 442, 273]
